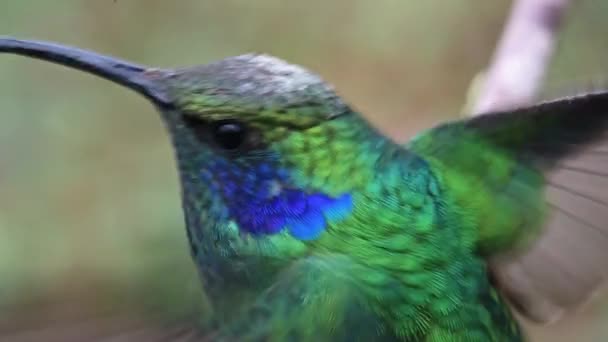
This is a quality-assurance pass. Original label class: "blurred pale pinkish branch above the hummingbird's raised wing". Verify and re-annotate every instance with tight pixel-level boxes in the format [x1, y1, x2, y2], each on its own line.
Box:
[470, 0, 573, 115]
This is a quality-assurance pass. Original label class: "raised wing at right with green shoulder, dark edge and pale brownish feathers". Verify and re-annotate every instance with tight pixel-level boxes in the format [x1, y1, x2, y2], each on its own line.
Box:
[408, 92, 608, 322]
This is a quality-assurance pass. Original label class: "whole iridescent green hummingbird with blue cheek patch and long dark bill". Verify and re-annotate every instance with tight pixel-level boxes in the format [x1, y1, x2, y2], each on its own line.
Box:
[0, 37, 608, 342]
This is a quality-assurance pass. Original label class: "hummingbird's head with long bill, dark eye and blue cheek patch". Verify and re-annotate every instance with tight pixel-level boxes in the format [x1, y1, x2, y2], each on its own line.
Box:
[0, 38, 386, 256]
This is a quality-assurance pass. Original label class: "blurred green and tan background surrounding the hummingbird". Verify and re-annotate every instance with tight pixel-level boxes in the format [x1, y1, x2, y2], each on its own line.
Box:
[0, 0, 608, 341]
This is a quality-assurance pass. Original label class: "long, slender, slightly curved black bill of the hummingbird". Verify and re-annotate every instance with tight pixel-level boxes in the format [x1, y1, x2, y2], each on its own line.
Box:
[0, 36, 169, 104]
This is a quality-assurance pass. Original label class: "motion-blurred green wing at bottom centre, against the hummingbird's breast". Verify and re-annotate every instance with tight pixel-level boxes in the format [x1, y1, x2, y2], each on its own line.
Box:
[213, 256, 379, 341]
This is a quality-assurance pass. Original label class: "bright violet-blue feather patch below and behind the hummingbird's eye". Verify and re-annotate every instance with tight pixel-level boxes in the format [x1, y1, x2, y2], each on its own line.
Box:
[201, 160, 353, 241]
